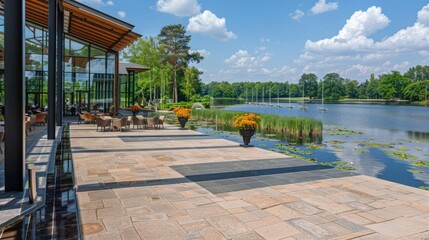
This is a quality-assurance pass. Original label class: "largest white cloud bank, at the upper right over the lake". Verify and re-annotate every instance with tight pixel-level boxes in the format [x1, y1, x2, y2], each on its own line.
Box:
[295, 4, 429, 80]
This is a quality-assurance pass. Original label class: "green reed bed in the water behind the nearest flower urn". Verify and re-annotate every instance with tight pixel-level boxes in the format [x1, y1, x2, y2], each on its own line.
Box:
[192, 109, 323, 137]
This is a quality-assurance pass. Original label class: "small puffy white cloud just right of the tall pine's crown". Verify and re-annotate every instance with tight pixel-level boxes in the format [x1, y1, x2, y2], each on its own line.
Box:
[186, 10, 237, 41]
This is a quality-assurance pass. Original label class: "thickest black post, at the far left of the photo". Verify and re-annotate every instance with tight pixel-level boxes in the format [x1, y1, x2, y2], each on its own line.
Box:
[4, 0, 25, 192]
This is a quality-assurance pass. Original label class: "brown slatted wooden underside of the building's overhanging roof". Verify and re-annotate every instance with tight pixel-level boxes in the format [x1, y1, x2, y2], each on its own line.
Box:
[25, 0, 141, 51]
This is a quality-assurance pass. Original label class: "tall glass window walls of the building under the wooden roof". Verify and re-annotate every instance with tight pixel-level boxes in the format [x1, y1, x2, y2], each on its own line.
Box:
[0, 16, 115, 115]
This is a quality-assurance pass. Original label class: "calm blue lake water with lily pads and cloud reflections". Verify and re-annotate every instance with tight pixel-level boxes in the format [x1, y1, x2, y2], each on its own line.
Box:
[212, 103, 429, 187]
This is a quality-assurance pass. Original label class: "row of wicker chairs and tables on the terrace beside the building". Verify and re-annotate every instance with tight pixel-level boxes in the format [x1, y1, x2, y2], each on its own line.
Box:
[78, 112, 165, 131]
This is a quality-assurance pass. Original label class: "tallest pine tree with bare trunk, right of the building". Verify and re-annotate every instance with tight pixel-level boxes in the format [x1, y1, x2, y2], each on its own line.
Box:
[158, 24, 203, 102]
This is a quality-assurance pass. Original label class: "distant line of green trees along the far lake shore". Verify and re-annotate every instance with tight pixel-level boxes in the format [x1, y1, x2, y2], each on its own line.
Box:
[200, 66, 429, 101]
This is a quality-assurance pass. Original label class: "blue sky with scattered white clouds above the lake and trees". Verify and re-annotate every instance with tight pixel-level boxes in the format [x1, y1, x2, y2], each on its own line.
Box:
[79, 0, 429, 83]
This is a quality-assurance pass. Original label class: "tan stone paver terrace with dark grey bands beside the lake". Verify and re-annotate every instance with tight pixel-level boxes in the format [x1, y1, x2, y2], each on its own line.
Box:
[71, 124, 429, 240]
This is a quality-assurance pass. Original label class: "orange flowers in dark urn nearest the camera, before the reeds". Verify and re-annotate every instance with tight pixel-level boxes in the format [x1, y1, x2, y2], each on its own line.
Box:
[232, 113, 261, 147]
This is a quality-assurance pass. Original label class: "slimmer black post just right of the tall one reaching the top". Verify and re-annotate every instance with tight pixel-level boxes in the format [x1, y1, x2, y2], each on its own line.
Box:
[57, 8, 63, 126]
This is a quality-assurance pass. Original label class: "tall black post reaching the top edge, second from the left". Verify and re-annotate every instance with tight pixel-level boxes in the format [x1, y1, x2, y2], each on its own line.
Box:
[48, 0, 56, 140]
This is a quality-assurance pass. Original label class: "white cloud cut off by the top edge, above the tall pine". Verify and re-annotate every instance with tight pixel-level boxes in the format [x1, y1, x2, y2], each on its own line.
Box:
[156, 0, 201, 17]
